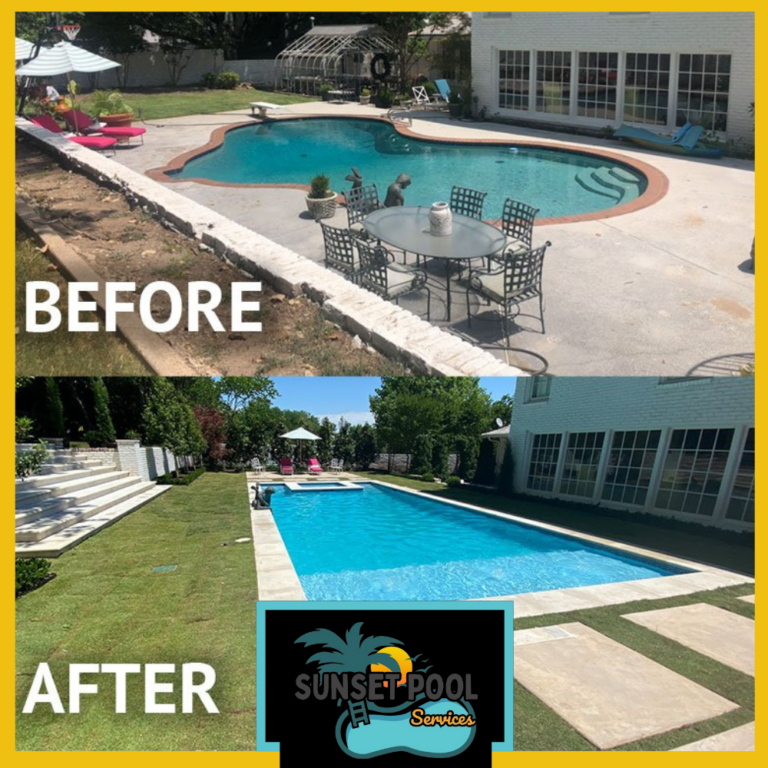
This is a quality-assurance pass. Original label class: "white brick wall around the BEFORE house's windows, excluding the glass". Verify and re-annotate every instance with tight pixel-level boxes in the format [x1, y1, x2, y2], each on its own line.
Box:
[472, 12, 755, 143]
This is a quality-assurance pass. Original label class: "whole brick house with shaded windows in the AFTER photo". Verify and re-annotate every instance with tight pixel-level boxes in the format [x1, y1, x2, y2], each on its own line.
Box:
[500, 377, 755, 530]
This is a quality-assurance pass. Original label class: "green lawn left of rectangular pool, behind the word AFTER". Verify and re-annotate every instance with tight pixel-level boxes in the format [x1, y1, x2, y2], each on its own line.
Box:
[16, 474, 256, 750]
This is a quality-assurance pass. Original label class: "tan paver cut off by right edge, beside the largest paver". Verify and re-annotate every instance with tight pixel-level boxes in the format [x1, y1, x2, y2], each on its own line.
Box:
[624, 603, 755, 677]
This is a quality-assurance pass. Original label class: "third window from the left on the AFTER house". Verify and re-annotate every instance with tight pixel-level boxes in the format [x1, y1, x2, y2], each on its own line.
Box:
[603, 430, 661, 506]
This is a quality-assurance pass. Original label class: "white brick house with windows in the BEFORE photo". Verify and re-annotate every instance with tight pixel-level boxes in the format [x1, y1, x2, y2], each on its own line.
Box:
[472, 12, 755, 144]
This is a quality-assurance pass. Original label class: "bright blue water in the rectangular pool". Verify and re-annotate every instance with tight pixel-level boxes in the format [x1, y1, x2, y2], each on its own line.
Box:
[272, 484, 685, 600]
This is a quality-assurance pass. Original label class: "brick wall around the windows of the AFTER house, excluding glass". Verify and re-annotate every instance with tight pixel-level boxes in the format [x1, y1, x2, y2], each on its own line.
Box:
[510, 377, 755, 529]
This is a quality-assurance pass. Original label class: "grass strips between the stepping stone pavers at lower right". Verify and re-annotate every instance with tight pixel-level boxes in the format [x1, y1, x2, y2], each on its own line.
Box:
[515, 584, 755, 751]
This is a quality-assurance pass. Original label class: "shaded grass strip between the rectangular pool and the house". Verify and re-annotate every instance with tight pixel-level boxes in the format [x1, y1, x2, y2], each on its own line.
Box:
[358, 472, 755, 575]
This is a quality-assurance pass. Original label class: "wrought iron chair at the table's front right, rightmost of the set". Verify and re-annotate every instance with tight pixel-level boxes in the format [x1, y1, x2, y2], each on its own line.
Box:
[467, 242, 552, 342]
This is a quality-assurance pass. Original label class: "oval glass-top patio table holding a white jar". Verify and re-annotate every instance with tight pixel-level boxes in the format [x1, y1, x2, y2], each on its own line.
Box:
[363, 206, 507, 321]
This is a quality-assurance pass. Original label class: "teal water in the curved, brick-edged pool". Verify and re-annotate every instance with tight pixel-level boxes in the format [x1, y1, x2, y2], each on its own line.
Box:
[168, 118, 647, 220]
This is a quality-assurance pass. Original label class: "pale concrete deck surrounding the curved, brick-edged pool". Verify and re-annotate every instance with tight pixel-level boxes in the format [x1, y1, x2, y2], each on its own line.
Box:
[116, 103, 755, 376]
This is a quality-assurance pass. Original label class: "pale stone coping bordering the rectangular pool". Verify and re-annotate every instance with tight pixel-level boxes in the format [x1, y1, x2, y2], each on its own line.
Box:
[247, 473, 755, 618]
